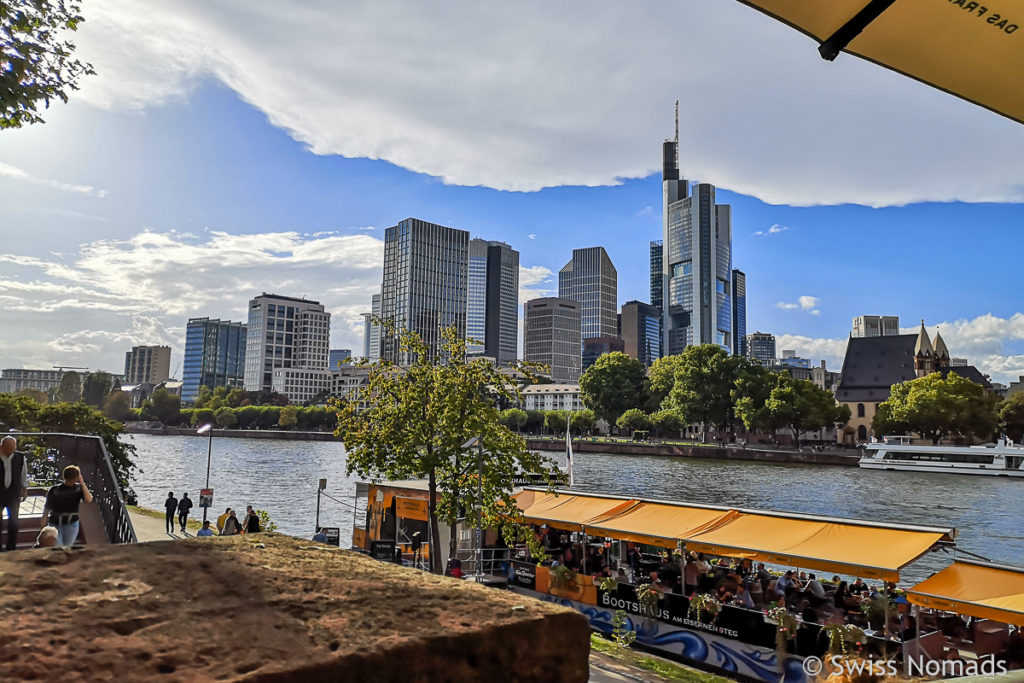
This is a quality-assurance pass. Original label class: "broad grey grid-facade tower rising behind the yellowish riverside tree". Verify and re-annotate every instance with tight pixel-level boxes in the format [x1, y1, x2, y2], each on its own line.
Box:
[380, 218, 469, 365]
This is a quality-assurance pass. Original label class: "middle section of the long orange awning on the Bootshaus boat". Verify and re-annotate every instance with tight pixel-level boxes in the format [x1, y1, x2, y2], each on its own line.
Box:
[587, 503, 738, 548]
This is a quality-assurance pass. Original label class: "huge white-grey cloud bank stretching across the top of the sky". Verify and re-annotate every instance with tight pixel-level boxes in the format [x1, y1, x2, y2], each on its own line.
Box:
[66, 0, 1024, 206]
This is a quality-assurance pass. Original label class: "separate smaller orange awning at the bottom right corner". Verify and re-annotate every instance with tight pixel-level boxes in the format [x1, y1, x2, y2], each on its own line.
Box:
[906, 560, 1024, 627]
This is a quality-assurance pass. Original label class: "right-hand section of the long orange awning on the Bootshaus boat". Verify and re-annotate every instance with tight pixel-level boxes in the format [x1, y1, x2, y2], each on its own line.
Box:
[686, 510, 953, 581]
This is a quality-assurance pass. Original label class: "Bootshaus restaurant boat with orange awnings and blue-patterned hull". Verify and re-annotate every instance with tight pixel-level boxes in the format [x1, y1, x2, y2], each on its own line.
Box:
[353, 481, 1024, 683]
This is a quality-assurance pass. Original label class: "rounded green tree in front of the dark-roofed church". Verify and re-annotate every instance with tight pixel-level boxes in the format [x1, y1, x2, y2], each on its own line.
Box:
[871, 373, 998, 443]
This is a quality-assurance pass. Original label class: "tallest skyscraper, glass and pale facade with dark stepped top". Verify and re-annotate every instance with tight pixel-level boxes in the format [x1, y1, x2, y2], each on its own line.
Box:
[662, 124, 733, 354]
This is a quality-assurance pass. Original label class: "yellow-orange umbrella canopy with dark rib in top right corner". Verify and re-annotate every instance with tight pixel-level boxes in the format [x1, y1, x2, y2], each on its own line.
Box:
[740, 0, 1024, 123]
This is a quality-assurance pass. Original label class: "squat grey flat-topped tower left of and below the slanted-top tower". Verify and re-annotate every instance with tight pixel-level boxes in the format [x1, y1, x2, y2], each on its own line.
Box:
[522, 297, 582, 382]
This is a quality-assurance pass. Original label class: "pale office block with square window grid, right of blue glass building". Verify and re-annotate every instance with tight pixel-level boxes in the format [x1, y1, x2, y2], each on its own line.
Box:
[245, 292, 331, 395]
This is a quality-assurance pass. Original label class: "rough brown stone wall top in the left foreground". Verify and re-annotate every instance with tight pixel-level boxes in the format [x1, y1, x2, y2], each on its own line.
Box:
[0, 533, 590, 683]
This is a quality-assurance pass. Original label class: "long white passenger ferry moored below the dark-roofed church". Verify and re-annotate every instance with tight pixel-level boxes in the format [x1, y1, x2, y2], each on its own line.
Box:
[859, 436, 1024, 477]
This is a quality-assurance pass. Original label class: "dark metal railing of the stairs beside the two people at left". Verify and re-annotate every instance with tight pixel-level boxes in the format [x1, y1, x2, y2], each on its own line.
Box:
[9, 432, 137, 543]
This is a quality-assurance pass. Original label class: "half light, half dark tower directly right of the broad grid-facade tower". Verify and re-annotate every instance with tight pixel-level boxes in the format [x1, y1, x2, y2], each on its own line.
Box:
[466, 239, 519, 364]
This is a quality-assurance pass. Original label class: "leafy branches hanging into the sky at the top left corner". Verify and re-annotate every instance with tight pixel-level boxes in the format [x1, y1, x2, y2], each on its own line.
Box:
[0, 0, 95, 130]
